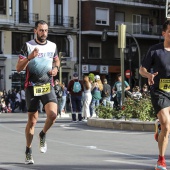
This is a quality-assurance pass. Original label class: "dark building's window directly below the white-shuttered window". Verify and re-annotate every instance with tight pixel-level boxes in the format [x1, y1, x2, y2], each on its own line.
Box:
[88, 43, 101, 59]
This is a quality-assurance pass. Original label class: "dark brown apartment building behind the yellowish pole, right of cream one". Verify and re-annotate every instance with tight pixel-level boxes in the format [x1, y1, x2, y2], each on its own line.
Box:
[81, 0, 166, 86]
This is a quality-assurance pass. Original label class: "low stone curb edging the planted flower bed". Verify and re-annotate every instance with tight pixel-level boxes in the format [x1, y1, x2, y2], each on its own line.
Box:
[87, 118, 155, 132]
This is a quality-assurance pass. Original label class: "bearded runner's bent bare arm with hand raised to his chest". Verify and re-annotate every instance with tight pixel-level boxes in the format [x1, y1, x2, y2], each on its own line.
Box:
[16, 48, 39, 72]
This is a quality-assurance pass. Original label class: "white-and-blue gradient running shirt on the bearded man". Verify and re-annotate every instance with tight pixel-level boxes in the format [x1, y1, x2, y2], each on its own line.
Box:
[19, 40, 58, 87]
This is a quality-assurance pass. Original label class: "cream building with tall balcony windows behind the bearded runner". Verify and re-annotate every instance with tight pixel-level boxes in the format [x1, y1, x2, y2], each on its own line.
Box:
[0, 0, 78, 90]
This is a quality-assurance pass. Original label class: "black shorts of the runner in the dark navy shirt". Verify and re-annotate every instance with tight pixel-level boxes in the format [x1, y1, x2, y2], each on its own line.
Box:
[151, 90, 170, 114]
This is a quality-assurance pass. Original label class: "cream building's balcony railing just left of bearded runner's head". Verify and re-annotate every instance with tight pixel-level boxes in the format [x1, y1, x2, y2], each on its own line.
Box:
[14, 12, 39, 25]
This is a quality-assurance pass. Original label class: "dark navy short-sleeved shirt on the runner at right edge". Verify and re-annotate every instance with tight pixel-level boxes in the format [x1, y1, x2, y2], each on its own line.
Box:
[142, 43, 170, 89]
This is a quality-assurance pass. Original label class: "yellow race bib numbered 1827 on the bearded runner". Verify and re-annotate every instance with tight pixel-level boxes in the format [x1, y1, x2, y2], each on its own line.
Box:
[34, 83, 51, 96]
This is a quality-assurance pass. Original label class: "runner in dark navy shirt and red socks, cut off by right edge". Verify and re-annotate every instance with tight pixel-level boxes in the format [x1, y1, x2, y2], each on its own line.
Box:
[139, 20, 170, 170]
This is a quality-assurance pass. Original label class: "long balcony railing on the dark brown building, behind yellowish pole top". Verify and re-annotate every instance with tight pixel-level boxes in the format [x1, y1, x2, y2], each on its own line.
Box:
[115, 21, 162, 36]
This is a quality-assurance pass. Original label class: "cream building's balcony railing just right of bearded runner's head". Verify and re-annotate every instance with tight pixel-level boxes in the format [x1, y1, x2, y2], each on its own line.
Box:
[47, 15, 74, 28]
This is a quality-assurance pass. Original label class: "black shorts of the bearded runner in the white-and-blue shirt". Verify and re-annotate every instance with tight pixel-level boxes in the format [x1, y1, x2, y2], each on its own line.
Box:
[25, 86, 57, 112]
